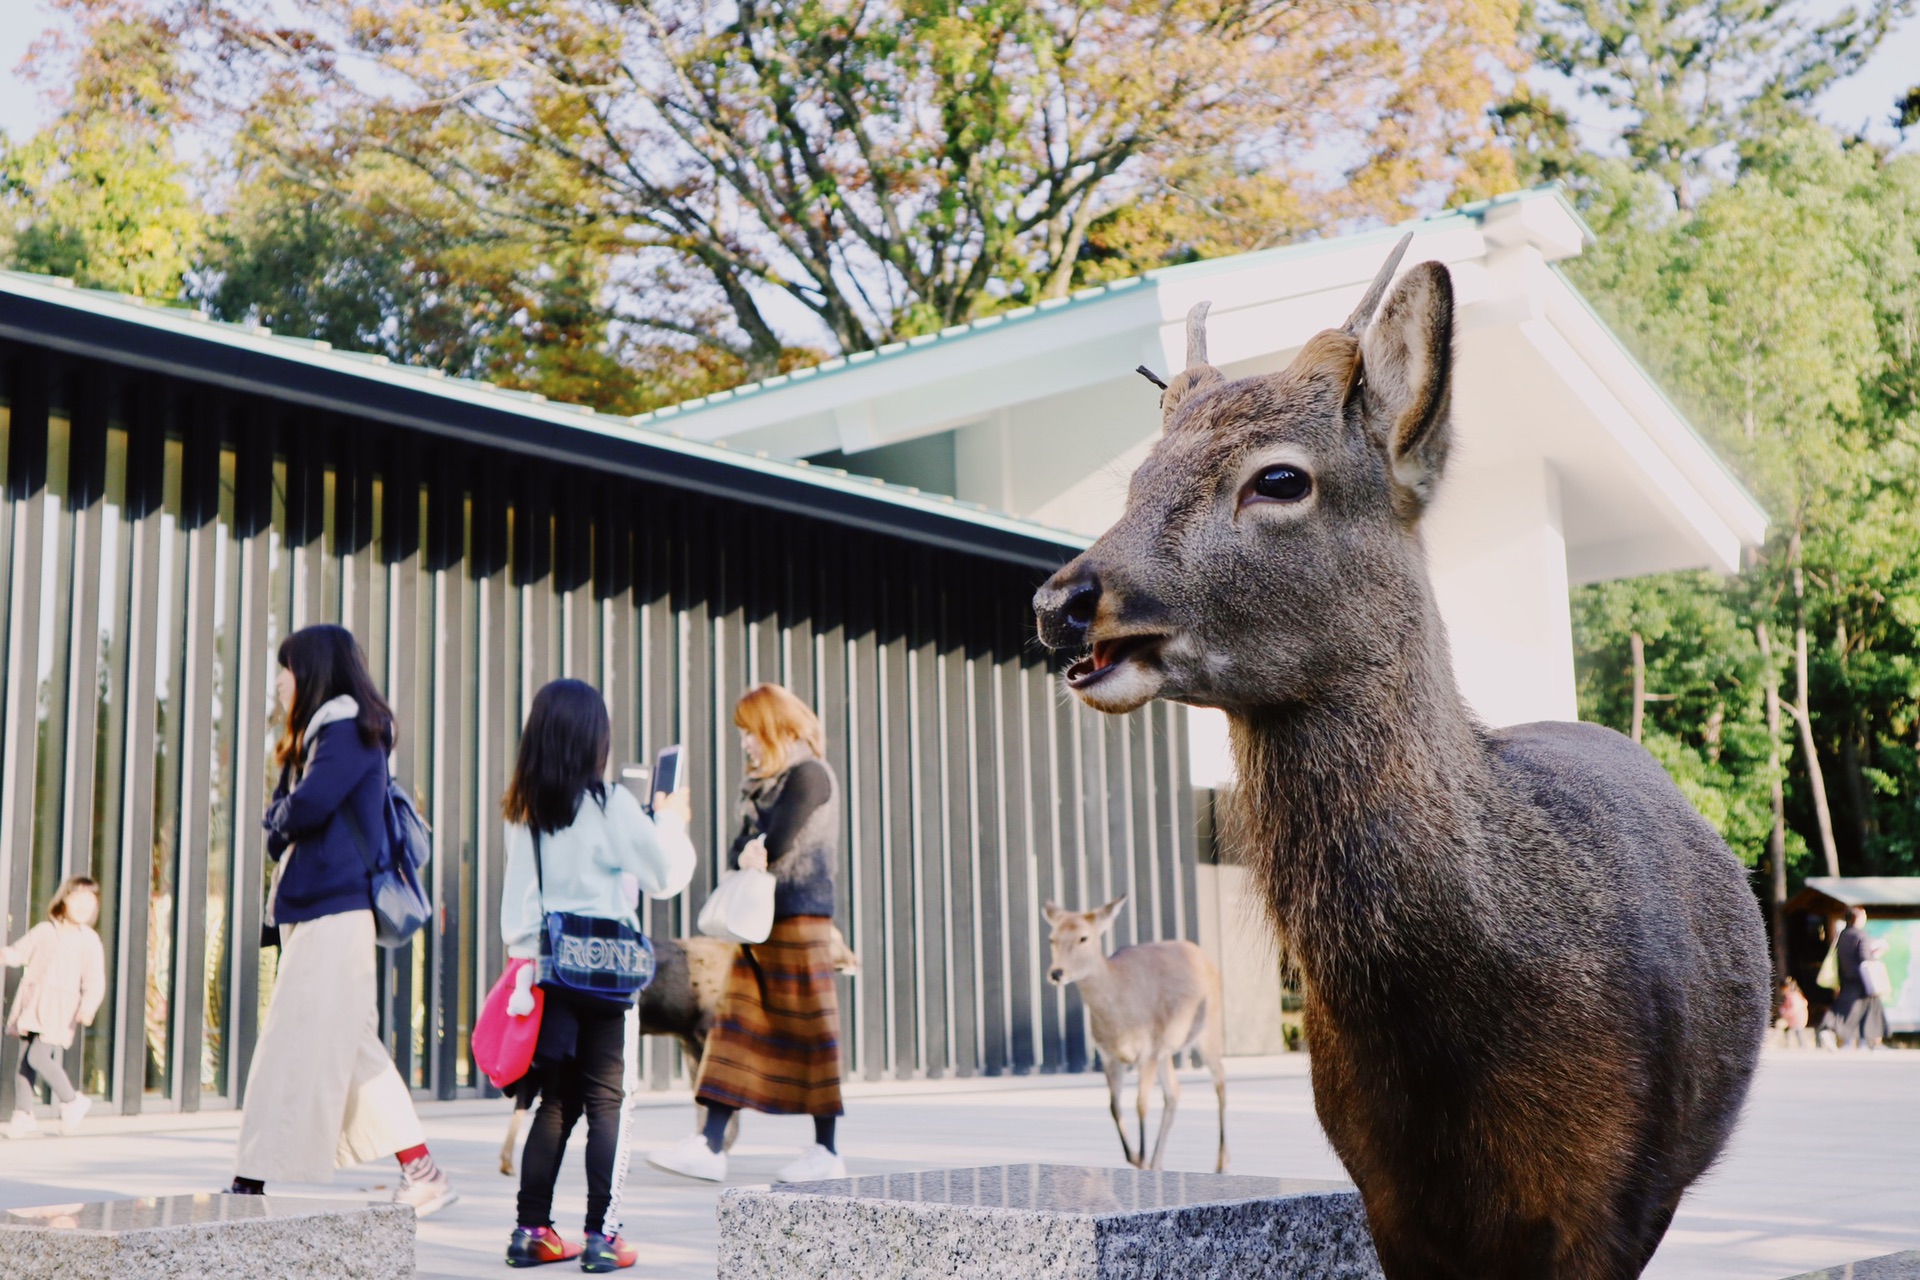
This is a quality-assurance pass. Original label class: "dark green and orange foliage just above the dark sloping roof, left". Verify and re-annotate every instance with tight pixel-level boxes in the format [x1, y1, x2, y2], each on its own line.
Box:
[192, 148, 820, 415]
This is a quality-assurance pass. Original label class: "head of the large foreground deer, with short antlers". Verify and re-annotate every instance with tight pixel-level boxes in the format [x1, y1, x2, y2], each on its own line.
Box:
[1033, 234, 1453, 721]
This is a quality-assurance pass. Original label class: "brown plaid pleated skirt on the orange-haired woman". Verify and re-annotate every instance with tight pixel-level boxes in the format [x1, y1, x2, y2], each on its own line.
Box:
[693, 915, 841, 1115]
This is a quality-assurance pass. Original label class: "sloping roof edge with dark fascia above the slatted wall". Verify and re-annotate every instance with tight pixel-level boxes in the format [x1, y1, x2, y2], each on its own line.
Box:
[0, 271, 1089, 568]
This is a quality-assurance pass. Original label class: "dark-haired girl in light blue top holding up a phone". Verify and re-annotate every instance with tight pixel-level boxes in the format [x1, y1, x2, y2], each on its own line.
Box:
[499, 679, 695, 1272]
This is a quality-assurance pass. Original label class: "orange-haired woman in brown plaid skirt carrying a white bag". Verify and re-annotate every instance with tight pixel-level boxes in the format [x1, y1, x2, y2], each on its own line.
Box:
[647, 685, 847, 1182]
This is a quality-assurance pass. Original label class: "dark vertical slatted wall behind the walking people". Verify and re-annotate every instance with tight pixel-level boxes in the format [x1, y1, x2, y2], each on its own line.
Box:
[0, 349, 1196, 1113]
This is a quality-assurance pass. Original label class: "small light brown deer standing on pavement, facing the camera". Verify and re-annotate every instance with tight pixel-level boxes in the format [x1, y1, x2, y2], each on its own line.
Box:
[1041, 894, 1227, 1173]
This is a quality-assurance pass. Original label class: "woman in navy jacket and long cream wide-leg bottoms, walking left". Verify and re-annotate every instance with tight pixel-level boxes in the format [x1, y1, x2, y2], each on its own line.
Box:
[230, 626, 457, 1217]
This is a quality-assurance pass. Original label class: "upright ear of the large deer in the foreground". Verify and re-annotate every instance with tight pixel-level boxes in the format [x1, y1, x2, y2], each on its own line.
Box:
[1359, 263, 1453, 520]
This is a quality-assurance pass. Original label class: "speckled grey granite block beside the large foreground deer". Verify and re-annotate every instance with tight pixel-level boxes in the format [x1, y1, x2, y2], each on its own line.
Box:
[716, 1165, 1380, 1280]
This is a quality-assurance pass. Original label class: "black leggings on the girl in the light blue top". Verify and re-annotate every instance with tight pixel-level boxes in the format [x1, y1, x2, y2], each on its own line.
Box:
[518, 986, 626, 1232]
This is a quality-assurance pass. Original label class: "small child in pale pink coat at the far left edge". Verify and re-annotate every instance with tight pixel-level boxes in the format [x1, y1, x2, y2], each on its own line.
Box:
[0, 875, 108, 1138]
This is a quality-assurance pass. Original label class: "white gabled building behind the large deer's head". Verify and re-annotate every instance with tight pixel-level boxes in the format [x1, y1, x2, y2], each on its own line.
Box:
[629, 188, 1766, 1048]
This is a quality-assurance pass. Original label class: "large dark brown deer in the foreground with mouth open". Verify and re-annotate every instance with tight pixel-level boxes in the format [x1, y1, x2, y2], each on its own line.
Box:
[1035, 240, 1768, 1280]
